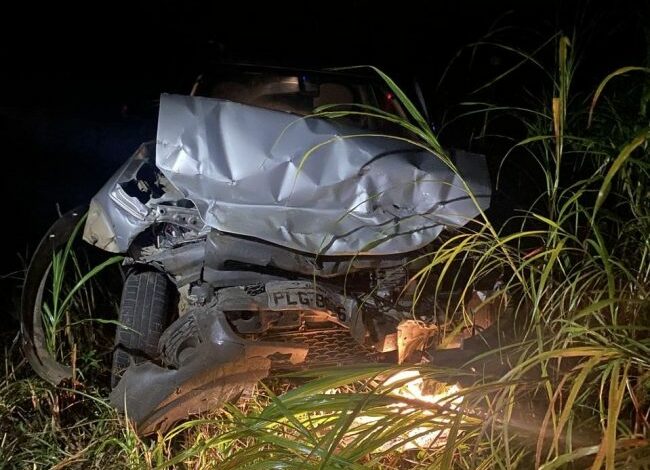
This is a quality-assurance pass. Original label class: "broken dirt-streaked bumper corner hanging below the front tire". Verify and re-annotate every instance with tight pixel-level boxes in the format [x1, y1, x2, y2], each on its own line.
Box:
[110, 306, 308, 434]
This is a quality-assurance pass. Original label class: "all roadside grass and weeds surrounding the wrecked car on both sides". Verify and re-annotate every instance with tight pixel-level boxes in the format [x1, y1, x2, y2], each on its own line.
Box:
[0, 31, 650, 469]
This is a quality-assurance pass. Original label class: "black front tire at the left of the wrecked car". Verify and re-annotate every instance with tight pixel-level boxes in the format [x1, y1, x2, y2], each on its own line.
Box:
[111, 271, 172, 387]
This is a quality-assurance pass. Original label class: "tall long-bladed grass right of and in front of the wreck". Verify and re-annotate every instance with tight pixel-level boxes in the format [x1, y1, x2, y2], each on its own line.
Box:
[168, 36, 650, 469]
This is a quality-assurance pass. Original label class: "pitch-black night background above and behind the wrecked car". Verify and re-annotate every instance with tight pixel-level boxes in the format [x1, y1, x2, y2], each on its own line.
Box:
[0, 0, 650, 324]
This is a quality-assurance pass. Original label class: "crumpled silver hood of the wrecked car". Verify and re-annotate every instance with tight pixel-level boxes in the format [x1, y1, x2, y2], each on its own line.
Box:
[156, 94, 490, 255]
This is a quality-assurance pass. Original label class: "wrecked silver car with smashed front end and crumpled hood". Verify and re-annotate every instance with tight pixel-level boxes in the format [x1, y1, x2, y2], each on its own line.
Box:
[22, 66, 491, 434]
